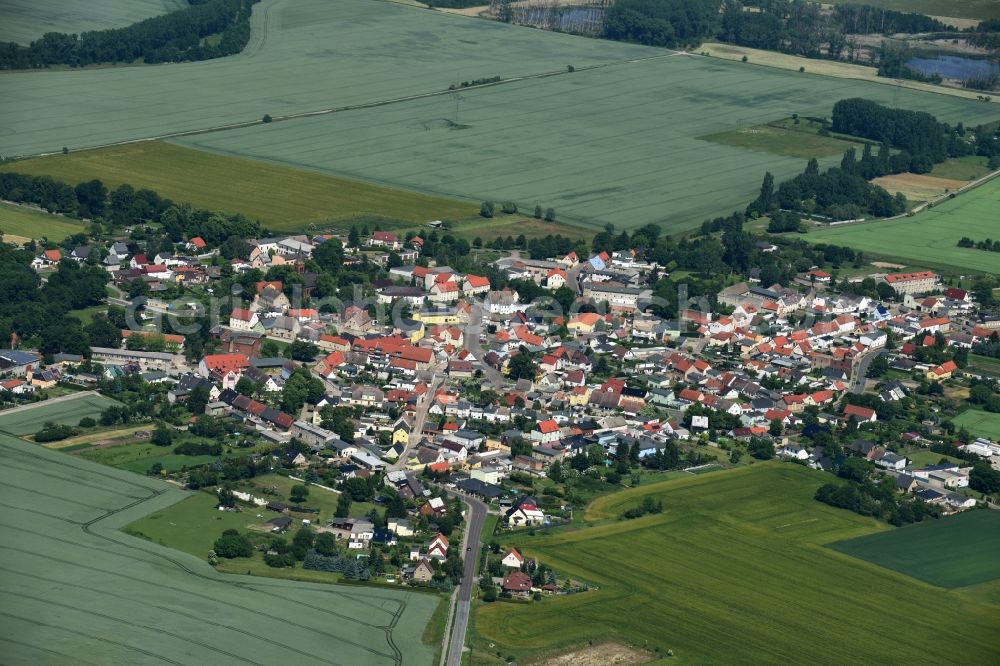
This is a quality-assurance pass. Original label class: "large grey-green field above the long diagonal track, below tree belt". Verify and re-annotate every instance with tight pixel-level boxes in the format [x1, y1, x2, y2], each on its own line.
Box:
[0, 0, 656, 156]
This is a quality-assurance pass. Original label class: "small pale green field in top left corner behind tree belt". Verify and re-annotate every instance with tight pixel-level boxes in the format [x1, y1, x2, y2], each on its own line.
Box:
[0, 0, 187, 44]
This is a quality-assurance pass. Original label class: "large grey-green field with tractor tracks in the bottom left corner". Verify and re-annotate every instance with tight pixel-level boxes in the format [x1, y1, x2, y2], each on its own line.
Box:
[0, 435, 438, 666]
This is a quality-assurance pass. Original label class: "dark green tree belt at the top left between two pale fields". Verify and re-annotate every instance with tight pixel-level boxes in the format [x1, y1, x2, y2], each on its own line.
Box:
[0, 0, 259, 69]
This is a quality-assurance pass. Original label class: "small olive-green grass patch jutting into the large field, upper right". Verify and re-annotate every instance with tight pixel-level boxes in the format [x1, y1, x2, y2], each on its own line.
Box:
[698, 118, 864, 160]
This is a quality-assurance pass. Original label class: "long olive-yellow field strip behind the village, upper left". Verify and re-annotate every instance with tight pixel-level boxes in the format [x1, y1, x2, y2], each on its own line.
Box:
[0, 141, 479, 235]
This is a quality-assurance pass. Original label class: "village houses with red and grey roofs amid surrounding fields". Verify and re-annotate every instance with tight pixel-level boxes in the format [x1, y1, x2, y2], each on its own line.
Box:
[0, 226, 1000, 583]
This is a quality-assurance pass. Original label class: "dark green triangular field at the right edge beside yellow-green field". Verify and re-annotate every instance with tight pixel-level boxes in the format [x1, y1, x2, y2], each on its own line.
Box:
[830, 511, 1000, 588]
